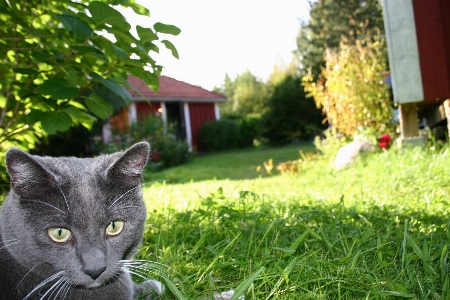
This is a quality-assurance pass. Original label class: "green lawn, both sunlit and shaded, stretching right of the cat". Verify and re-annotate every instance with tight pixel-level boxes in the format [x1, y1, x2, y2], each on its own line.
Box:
[140, 145, 450, 299]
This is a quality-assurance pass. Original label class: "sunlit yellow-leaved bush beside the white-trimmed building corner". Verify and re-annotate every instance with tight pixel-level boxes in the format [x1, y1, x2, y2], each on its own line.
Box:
[303, 32, 395, 136]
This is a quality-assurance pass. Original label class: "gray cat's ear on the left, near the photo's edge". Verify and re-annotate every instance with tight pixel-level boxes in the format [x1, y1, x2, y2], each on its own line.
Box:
[6, 148, 55, 196]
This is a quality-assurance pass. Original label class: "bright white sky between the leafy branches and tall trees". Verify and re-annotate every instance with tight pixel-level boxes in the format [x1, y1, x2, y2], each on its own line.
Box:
[124, 0, 309, 90]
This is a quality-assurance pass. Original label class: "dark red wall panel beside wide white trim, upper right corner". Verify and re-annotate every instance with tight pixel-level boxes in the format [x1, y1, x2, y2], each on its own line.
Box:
[414, 0, 450, 100]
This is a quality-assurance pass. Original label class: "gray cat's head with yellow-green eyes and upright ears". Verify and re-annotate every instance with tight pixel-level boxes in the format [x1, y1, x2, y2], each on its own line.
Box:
[0, 142, 150, 288]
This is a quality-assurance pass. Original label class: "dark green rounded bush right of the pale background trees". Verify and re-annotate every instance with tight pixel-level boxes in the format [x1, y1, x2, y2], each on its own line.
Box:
[262, 75, 323, 145]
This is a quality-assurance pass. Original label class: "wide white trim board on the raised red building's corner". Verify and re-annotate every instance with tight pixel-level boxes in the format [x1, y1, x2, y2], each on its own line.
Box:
[383, 0, 424, 104]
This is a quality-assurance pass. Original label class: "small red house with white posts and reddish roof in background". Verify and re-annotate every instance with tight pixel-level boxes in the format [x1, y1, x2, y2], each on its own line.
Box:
[103, 76, 227, 151]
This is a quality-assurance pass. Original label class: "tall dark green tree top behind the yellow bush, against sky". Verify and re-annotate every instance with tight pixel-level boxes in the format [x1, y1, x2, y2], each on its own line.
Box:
[296, 0, 384, 77]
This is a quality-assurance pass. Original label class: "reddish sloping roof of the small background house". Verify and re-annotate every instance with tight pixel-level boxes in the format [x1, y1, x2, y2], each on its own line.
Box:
[128, 75, 227, 102]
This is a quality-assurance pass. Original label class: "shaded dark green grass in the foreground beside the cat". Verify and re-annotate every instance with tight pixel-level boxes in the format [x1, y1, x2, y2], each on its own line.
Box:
[141, 189, 450, 299]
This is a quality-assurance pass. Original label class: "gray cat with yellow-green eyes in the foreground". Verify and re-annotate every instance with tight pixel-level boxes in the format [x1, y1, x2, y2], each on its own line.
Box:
[0, 142, 163, 300]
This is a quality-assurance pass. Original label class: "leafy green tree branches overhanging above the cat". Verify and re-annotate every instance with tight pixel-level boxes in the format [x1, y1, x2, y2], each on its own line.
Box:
[0, 0, 180, 166]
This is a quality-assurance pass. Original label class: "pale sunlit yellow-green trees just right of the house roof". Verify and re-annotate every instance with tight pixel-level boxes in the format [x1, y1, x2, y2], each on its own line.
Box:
[214, 71, 267, 115]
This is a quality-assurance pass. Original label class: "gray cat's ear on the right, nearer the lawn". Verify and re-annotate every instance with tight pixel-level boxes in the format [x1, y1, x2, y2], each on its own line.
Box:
[106, 142, 150, 185]
